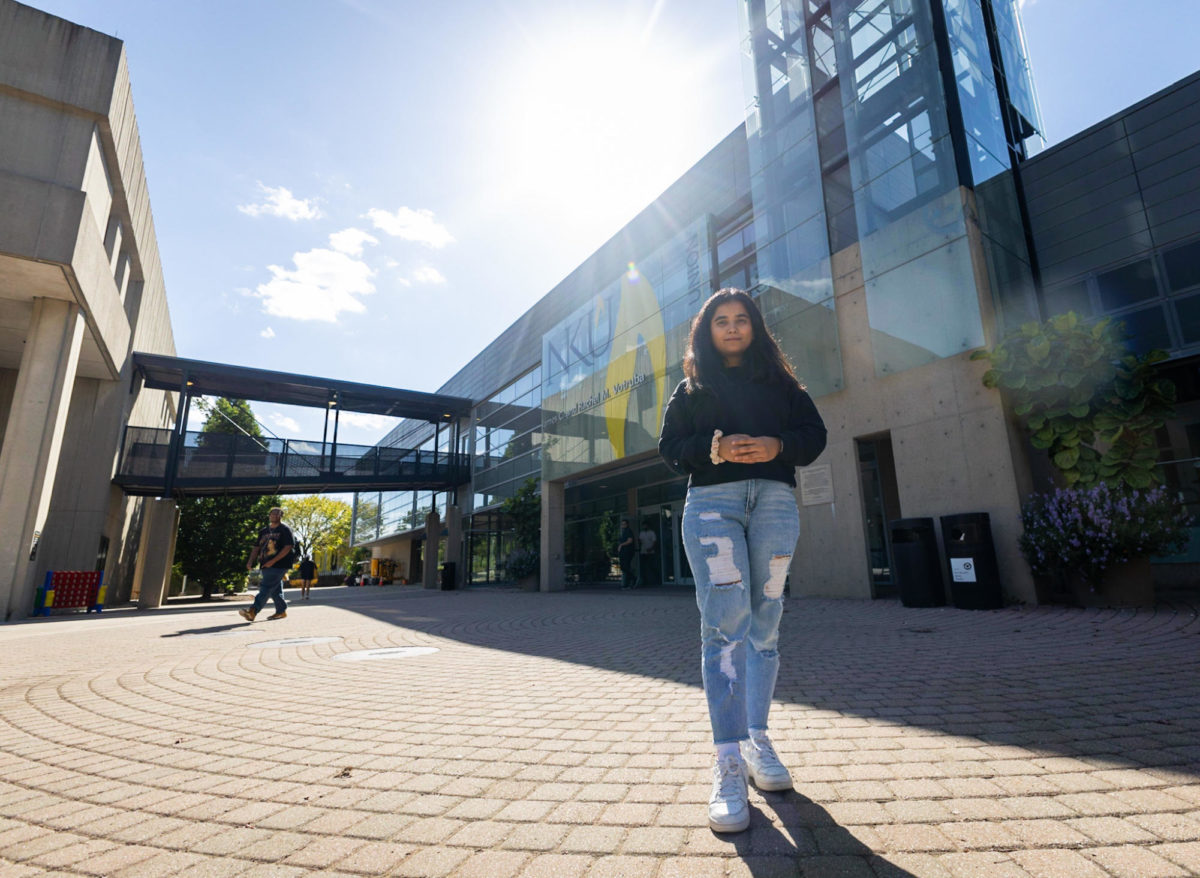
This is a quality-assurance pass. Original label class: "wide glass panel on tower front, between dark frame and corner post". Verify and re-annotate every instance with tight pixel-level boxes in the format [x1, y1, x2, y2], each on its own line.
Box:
[830, 0, 984, 374]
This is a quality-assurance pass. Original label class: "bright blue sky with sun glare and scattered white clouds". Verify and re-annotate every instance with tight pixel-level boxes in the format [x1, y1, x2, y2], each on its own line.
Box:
[25, 0, 1200, 443]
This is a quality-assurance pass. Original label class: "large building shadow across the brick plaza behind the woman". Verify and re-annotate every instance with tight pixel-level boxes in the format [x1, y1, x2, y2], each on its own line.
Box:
[316, 589, 1200, 776]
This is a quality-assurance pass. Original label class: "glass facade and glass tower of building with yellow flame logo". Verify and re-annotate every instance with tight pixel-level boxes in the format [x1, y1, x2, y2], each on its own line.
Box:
[355, 0, 1070, 583]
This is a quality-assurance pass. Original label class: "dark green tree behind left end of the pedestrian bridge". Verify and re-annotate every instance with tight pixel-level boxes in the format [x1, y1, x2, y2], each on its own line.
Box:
[175, 398, 278, 600]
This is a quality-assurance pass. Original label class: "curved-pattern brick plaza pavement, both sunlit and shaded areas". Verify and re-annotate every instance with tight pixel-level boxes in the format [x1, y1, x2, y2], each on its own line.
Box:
[0, 587, 1200, 878]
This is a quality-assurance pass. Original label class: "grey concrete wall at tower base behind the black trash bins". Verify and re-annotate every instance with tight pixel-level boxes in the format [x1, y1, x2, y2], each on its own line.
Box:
[791, 192, 1036, 603]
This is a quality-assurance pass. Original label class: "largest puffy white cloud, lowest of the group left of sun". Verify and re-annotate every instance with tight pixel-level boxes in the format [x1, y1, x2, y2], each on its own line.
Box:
[254, 247, 374, 323]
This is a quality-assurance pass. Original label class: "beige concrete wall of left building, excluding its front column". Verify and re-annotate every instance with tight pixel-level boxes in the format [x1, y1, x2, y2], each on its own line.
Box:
[0, 0, 175, 618]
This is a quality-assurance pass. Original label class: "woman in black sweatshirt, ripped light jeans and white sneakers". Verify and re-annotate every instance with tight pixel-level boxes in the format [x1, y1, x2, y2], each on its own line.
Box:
[659, 288, 826, 832]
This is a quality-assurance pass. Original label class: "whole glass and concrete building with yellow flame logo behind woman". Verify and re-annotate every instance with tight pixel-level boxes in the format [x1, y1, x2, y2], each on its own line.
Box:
[354, 0, 1200, 602]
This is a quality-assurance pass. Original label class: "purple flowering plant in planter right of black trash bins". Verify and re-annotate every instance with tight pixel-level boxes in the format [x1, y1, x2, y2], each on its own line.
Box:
[1020, 482, 1190, 587]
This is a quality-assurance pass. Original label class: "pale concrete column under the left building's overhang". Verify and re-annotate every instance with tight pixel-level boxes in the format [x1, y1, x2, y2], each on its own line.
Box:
[0, 299, 84, 621]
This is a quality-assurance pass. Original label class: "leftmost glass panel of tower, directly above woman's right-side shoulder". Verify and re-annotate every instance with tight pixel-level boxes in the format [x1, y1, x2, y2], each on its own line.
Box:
[740, 0, 852, 396]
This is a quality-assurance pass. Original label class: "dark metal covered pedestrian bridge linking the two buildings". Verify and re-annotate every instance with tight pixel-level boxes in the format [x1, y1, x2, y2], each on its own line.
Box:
[113, 354, 470, 498]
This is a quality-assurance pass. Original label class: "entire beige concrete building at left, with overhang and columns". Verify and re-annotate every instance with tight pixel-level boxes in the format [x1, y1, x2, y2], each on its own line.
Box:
[0, 0, 175, 619]
